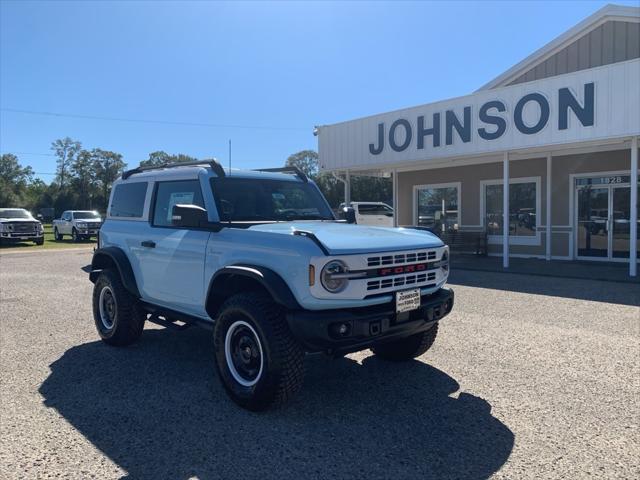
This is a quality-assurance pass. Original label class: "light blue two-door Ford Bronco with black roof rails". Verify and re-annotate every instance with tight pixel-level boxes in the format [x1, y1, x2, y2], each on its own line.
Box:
[85, 161, 454, 410]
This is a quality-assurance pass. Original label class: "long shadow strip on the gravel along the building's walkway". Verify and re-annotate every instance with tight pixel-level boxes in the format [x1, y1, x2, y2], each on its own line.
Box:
[449, 269, 640, 306]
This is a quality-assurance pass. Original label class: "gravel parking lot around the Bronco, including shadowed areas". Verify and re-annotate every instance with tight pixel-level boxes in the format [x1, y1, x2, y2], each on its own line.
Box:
[0, 250, 640, 480]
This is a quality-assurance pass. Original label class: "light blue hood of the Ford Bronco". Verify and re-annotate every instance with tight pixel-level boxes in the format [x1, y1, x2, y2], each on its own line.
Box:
[250, 221, 443, 255]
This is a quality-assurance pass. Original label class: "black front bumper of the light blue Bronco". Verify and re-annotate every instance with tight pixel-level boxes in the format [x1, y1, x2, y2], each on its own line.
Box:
[287, 288, 454, 354]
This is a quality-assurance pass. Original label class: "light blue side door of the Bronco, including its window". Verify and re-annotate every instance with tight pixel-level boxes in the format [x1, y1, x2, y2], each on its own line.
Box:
[137, 180, 210, 316]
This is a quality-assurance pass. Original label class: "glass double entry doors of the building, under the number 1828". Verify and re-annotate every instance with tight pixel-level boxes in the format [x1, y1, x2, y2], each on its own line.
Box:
[576, 177, 640, 260]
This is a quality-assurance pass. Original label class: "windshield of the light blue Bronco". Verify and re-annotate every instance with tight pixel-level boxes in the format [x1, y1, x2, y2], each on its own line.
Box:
[211, 177, 334, 222]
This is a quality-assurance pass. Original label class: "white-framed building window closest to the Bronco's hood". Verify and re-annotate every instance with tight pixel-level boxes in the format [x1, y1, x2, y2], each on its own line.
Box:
[414, 183, 460, 232]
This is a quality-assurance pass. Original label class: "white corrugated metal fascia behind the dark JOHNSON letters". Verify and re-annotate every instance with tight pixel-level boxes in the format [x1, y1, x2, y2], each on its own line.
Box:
[319, 59, 640, 170]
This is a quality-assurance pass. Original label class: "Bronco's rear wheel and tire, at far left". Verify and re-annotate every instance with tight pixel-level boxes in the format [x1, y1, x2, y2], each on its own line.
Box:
[93, 269, 146, 347]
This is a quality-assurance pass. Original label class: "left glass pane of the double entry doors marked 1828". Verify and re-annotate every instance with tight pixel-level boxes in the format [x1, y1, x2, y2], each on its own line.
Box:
[577, 186, 609, 258]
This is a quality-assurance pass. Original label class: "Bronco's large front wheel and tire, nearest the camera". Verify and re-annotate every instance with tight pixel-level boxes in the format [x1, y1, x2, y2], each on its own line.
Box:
[213, 293, 304, 411]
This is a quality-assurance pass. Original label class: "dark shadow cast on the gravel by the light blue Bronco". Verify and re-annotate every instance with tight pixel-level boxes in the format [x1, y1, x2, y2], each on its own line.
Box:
[40, 329, 514, 480]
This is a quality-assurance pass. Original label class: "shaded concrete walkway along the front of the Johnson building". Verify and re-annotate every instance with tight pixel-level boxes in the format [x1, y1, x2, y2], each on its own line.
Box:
[451, 252, 640, 284]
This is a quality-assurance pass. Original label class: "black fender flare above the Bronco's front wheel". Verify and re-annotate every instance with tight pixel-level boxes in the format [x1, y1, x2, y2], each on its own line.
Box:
[207, 264, 301, 318]
